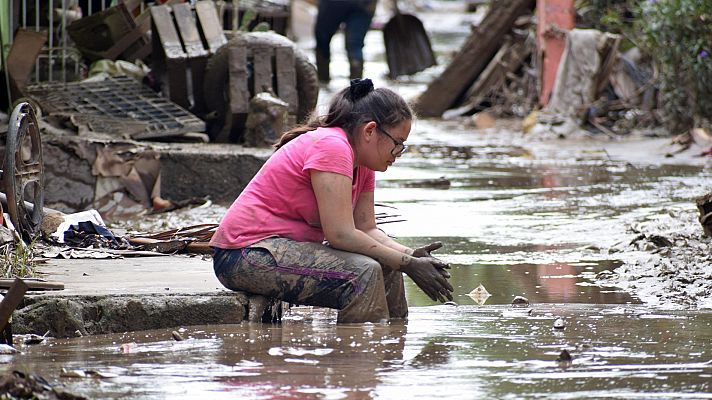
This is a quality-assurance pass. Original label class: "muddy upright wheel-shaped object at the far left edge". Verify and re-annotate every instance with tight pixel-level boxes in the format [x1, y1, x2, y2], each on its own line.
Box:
[0, 103, 44, 241]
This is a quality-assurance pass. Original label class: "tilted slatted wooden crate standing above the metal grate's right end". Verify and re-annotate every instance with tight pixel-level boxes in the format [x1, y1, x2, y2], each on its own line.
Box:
[150, 0, 227, 116]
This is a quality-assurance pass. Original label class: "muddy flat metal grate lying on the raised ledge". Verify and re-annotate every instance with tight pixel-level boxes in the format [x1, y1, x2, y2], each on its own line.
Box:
[27, 76, 205, 139]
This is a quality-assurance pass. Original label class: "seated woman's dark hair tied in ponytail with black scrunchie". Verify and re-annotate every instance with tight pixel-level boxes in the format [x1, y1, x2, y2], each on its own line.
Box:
[274, 79, 413, 149]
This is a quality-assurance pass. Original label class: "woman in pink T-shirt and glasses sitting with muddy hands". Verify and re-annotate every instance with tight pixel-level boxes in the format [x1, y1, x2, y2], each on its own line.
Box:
[210, 79, 453, 323]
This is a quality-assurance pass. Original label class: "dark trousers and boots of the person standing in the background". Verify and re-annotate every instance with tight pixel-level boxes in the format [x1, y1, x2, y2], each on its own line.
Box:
[314, 0, 376, 82]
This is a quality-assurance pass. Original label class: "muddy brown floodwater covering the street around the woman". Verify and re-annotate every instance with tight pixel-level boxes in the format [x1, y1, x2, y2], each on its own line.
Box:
[5, 114, 712, 399]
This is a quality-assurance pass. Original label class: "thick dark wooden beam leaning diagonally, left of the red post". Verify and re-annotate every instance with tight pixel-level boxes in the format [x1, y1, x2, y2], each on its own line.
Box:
[414, 0, 535, 117]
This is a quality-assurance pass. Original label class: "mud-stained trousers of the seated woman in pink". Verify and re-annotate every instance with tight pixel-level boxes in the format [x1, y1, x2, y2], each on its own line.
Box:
[213, 238, 408, 323]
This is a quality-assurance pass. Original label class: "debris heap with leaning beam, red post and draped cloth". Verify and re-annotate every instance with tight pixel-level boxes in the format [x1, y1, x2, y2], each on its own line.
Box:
[415, 0, 660, 137]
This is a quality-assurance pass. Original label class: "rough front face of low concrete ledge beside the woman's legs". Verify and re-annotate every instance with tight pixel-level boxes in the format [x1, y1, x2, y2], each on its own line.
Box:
[12, 292, 248, 338]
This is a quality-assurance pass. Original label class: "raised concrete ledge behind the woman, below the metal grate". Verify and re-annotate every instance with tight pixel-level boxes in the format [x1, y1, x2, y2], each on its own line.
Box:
[42, 135, 272, 217]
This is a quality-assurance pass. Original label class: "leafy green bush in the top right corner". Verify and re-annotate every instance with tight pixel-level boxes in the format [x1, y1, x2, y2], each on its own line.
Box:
[576, 0, 712, 134]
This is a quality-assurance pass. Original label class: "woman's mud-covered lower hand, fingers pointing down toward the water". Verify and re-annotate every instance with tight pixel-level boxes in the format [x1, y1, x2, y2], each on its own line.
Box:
[402, 257, 453, 303]
